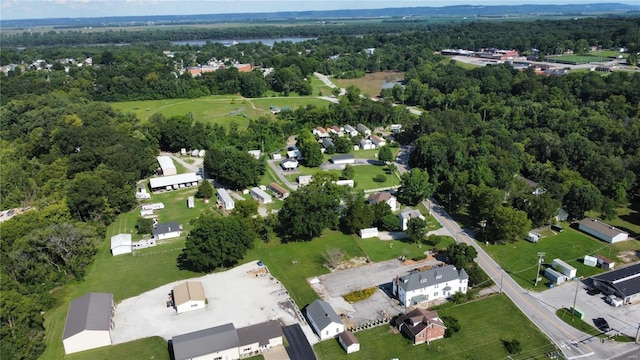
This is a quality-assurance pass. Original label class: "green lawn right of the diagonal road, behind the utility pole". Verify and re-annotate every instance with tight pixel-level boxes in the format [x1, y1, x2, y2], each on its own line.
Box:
[483, 224, 640, 290]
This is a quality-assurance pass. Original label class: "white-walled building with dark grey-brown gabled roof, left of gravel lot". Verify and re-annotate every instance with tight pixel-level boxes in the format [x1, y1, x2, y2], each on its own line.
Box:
[62, 293, 115, 354]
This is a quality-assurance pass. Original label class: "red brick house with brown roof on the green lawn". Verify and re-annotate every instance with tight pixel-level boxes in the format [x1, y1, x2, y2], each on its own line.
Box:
[394, 308, 447, 345]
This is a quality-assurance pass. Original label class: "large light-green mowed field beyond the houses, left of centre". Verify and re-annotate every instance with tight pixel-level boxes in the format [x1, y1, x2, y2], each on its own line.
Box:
[111, 95, 329, 127]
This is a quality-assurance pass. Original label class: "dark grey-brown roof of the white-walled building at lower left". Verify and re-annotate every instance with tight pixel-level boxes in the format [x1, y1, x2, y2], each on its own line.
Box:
[62, 293, 113, 339]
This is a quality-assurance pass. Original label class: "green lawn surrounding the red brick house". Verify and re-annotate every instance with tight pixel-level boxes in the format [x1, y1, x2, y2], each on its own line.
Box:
[314, 295, 555, 360]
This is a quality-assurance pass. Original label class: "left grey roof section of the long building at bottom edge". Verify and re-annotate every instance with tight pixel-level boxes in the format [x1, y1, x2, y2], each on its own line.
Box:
[172, 323, 240, 360]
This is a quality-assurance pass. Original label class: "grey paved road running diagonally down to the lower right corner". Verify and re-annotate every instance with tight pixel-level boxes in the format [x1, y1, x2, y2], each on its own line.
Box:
[396, 147, 640, 360]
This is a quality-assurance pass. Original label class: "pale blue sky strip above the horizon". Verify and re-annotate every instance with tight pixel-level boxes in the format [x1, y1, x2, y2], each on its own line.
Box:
[0, 0, 640, 20]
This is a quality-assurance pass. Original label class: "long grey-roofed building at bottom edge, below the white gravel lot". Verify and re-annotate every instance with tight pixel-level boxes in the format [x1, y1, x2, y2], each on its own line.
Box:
[171, 320, 283, 360]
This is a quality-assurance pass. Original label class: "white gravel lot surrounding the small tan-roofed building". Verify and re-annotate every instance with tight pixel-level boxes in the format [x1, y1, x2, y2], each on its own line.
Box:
[112, 260, 312, 344]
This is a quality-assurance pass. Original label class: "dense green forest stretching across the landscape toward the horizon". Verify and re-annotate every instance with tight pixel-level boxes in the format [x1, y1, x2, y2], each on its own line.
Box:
[0, 18, 640, 359]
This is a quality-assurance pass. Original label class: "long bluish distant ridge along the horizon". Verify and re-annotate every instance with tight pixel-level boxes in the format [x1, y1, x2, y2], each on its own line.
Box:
[0, 3, 640, 29]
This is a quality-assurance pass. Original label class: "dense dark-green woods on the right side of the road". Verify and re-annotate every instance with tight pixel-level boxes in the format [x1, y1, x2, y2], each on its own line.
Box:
[389, 63, 640, 242]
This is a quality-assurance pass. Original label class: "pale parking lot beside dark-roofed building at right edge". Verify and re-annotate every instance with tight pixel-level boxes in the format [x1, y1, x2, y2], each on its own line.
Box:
[530, 281, 640, 337]
